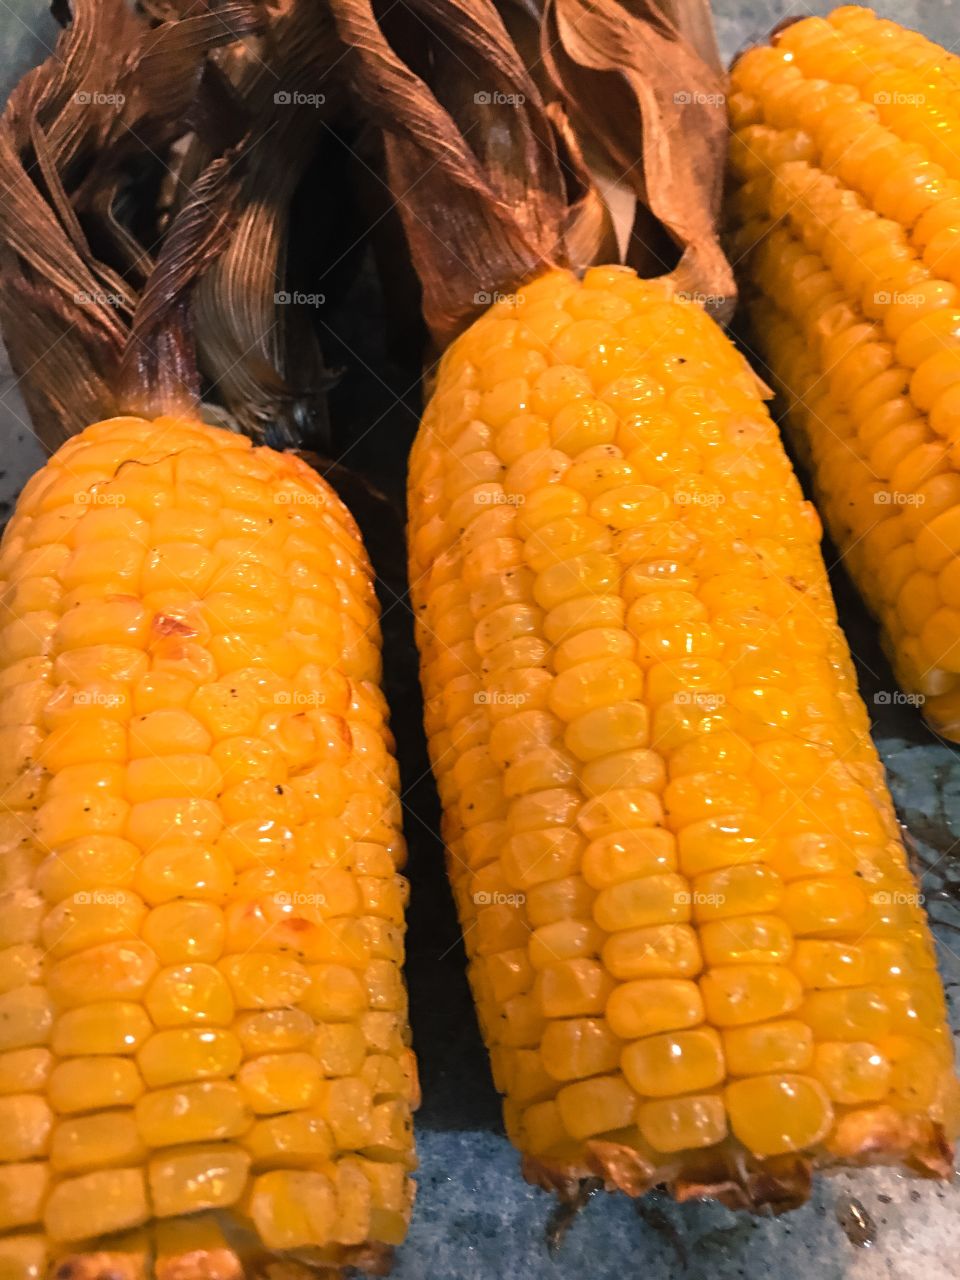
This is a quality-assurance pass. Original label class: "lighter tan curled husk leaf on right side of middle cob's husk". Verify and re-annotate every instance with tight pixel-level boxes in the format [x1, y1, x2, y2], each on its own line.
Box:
[540, 0, 736, 319]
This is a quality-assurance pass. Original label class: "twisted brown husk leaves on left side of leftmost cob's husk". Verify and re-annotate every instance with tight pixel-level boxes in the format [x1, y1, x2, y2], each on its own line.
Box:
[0, 0, 261, 448]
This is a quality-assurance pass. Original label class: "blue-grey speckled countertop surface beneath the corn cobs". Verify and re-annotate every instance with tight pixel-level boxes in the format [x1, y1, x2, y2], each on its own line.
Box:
[0, 0, 960, 1280]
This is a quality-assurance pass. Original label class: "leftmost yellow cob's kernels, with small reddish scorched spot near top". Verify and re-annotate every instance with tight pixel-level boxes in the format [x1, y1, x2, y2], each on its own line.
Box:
[0, 419, 417, 1280]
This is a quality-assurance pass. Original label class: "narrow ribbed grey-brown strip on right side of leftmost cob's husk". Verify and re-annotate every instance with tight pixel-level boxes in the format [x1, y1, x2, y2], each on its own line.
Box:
[193, 0, 340, 447]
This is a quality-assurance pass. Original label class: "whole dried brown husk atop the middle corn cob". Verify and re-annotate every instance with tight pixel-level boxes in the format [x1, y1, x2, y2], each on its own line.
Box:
[330, 0, 733, 344]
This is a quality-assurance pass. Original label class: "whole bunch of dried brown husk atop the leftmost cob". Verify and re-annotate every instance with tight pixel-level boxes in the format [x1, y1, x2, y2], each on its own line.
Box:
[0, 0, 339, 449]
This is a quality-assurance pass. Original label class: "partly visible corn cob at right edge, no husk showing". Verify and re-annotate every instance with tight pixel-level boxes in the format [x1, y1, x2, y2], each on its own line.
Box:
[730, 6, 960, 740]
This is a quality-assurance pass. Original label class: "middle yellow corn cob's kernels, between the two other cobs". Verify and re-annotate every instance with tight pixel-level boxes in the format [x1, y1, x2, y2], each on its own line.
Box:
[410, 268, 956, 1203]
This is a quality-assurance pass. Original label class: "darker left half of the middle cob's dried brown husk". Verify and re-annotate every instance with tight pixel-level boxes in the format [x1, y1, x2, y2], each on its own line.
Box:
[332, 0, 596, 346]
